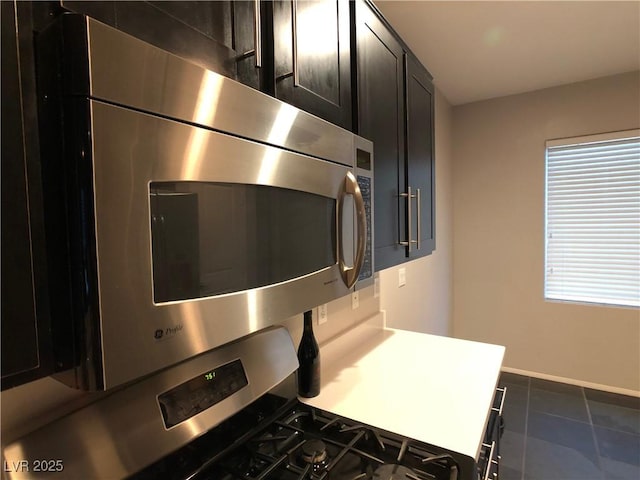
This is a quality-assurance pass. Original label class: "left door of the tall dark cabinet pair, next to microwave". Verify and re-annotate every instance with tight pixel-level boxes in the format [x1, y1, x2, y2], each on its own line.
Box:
[356, 2, 406, 270]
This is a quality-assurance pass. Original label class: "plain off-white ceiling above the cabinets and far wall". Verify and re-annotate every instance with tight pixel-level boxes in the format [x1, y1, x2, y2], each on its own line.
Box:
[374, 0, 640, 105]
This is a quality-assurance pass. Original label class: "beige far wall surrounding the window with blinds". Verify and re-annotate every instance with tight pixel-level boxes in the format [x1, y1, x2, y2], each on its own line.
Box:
[453, 72, 640, 392]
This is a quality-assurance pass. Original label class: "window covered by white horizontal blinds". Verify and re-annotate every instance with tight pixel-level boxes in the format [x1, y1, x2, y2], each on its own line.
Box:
[545, 130, 640, 307]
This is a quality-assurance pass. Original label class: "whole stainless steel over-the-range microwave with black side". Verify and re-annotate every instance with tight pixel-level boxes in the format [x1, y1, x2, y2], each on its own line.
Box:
[37, 15, 373, 390]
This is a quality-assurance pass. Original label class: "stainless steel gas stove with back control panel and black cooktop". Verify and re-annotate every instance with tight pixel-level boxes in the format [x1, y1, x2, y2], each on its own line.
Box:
[3, 327, 460, 480]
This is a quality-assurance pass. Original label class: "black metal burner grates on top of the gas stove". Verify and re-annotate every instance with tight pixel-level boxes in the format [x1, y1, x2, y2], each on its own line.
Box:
[199, 404, 457, 480]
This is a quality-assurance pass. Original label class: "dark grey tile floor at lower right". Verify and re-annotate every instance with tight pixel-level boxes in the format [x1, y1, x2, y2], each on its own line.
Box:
[500, 373, 640, 480]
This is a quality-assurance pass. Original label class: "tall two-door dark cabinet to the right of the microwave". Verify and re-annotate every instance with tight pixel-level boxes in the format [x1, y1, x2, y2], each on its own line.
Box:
[356, 1, 435, 270]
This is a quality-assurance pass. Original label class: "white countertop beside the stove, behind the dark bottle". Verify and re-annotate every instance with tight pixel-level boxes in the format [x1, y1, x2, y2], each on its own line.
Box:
[300, 316, 505, 459]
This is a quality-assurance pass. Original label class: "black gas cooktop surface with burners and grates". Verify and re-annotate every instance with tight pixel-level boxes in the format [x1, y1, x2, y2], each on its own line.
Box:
[133, 394, 458, 480]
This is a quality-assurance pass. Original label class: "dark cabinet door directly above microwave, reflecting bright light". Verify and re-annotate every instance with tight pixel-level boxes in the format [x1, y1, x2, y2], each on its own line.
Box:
[272, 0, 352, 130]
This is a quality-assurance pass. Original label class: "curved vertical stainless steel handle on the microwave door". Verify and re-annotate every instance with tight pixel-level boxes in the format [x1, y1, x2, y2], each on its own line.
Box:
[337, 172, 367, 288]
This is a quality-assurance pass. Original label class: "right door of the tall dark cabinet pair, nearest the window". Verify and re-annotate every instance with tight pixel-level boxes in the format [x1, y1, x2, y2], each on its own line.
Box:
[405, 54, 435, 258]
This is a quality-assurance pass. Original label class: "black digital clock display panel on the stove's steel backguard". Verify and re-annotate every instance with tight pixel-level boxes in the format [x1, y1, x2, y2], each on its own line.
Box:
[158, 360, 249, 428]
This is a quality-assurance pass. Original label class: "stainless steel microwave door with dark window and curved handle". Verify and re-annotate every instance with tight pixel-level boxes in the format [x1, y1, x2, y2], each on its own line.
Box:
[91, 100, 367, 388]
